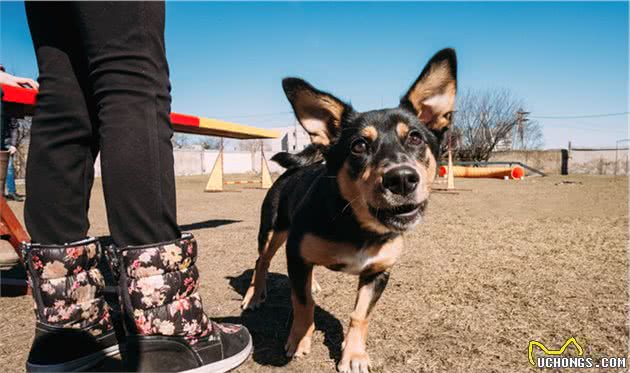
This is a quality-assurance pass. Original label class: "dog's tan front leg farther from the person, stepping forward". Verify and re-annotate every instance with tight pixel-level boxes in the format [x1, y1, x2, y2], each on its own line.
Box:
[337, 272, 389, 373]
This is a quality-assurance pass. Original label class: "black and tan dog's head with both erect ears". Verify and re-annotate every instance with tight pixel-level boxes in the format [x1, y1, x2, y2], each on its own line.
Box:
[282, 49, 457, 233]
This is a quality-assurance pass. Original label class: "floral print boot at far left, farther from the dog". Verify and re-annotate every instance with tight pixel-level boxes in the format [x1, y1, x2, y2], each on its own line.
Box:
[22, 238, 119, 372]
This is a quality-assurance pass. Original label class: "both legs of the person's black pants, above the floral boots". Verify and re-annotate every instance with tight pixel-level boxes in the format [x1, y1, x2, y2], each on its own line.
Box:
[24, 2, 180, 246]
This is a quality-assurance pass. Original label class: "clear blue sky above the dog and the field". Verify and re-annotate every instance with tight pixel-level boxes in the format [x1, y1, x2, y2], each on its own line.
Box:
[0, 2, 630, 148]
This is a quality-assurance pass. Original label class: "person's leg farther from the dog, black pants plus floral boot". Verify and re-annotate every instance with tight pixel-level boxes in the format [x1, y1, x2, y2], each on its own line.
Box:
[23, 2, 119, 372]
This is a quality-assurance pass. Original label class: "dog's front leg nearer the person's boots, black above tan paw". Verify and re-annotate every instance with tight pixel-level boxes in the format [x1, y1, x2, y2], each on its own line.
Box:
[285, 239, 315, 357]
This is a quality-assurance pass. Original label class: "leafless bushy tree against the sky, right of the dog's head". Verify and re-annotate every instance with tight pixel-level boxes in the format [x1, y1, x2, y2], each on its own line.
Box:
[447, 90, 542, 161]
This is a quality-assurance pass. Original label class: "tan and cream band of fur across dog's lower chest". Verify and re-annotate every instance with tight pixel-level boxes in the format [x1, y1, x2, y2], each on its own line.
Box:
[300, 234, 403, 275]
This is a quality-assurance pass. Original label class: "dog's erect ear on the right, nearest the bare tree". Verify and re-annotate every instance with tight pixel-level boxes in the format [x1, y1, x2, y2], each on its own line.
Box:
[400, 48, 457, 132]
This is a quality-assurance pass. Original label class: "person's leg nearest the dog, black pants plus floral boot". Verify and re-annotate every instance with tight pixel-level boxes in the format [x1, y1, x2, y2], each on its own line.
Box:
[72, 2, 252, 372]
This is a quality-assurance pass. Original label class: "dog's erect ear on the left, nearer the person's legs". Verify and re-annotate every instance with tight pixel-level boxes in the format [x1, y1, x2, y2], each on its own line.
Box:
[282, 78, 349, 146]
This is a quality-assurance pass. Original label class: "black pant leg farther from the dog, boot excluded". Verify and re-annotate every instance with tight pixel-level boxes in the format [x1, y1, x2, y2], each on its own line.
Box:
[24, 2, 98, 244]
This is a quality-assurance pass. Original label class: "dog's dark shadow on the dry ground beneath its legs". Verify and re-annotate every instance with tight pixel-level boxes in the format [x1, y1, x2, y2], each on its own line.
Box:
[225, 269, 343, 367]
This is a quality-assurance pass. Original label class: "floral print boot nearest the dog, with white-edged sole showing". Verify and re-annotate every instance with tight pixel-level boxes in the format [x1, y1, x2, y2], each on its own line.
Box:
[109, 234, 252, 373]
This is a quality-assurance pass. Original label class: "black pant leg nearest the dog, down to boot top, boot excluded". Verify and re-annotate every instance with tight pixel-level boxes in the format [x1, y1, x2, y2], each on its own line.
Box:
[73, 2, 181, 246]
